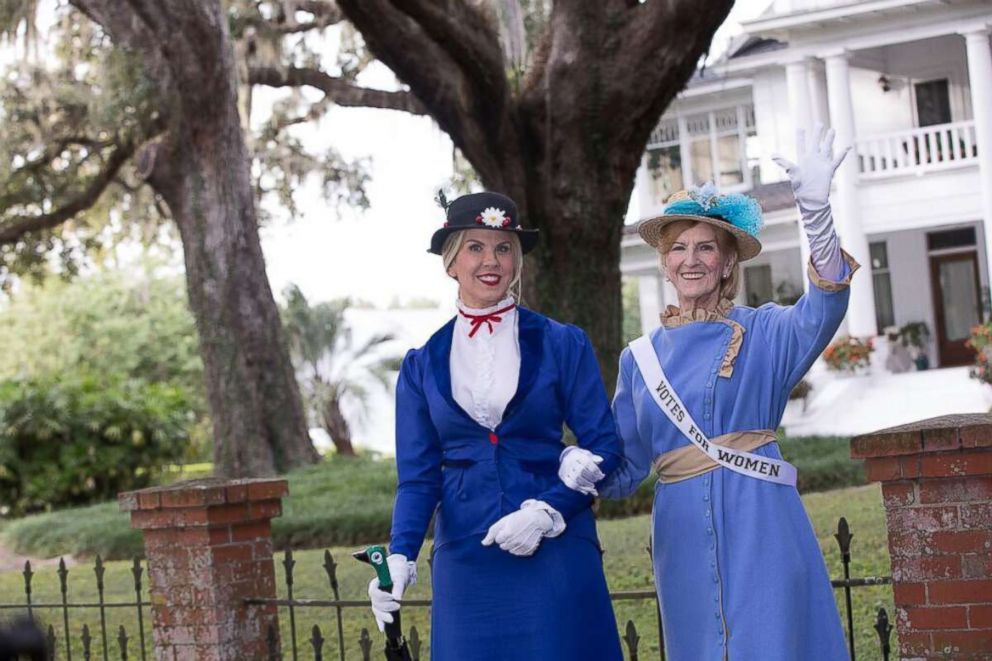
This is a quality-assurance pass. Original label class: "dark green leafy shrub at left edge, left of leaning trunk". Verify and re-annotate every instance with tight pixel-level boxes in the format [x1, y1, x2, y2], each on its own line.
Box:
[0, 374, 195, 516]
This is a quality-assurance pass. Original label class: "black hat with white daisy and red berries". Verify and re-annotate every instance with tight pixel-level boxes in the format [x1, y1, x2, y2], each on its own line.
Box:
[427, 192, 538, 255]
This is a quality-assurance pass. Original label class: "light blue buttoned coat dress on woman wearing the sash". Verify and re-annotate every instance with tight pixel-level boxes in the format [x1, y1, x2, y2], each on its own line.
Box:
[598, 264, 856, 661]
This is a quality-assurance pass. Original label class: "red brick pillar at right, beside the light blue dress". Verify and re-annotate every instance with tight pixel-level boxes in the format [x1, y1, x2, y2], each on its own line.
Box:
[851, 414, 992, 659]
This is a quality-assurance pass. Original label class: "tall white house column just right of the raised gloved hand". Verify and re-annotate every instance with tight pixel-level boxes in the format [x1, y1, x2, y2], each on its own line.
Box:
[820, 53, 876, 337]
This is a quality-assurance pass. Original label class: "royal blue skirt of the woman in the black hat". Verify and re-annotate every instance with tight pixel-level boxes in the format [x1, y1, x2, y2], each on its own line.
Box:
[431, 532, 623, 661]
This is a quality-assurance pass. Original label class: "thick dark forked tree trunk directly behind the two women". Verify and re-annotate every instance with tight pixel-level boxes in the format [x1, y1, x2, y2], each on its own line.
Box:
[338, 0, 733, 388]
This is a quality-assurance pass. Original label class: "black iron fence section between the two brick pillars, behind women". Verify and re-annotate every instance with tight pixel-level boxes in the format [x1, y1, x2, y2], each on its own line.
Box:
[246, 517, 892, 661]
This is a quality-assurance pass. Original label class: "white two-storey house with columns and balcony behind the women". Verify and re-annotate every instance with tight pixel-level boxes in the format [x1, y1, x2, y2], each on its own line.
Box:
[621, 0, 992, 366]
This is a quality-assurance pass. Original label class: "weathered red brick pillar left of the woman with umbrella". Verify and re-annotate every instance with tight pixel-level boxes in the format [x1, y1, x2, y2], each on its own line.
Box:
[118, 479, 289, 661]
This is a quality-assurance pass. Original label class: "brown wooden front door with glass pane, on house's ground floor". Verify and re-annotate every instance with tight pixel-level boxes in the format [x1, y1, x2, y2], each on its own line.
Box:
[930, 252, 982, 367]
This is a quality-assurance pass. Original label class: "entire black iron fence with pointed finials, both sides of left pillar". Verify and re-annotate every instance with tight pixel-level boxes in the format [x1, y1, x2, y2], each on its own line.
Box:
[0, 518, 892, 661]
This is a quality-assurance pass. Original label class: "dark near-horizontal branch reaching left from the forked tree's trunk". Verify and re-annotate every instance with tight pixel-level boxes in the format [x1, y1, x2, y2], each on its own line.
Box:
[248, 67, 427, 115]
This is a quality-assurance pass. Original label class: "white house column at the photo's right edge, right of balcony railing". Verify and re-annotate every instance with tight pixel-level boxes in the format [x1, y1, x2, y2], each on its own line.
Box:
[964, 28, 992, 282]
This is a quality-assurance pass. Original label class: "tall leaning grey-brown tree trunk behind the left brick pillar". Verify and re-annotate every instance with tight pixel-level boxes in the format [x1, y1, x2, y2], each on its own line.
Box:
[73, 0, 318, 477]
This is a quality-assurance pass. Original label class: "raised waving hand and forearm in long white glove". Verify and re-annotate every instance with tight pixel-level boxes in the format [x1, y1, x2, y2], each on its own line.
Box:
[772, 124, 851, 281]
